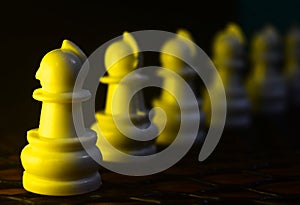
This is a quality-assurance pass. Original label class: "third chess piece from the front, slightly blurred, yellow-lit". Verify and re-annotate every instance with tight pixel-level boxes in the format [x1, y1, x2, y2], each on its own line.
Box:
[152, 29, 204, 147]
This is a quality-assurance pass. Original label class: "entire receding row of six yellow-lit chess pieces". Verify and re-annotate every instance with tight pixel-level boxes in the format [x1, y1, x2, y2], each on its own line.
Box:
[21, 24, 300, 195]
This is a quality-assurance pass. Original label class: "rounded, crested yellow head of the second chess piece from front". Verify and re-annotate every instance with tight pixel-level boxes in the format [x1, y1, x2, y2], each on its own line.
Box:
[104, 32, 139, 77]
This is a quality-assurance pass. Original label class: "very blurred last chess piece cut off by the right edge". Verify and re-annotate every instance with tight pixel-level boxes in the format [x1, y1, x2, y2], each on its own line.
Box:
[285, 27, 300, 110]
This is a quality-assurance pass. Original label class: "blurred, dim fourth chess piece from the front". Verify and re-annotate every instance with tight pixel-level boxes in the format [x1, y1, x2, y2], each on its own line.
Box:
[204, 23, 251, 129]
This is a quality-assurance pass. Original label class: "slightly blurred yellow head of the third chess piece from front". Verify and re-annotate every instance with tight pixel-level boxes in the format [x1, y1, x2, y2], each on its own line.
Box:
[160, 29, 196, 71]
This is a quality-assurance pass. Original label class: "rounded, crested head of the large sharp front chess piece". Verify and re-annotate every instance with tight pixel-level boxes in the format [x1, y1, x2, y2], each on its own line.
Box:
[35, 40, 86, 93]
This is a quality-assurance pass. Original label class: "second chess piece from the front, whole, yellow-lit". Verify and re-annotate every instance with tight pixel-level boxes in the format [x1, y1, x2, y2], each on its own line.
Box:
[92, 32, 157, 163]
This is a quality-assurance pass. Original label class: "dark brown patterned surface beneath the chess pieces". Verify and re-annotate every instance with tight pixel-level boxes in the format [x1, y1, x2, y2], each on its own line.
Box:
[0, 115, 300, 205]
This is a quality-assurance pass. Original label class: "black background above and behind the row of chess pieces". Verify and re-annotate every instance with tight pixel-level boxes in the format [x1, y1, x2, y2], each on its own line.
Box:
[0, 0, 300, 140]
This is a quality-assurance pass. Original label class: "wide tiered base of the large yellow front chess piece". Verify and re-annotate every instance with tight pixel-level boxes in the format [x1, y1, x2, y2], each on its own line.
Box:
[21, 129, 101, 196]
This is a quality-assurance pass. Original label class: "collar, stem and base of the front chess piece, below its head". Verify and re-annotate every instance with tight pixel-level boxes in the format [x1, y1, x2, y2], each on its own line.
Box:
[21, 89, 101, 196]
